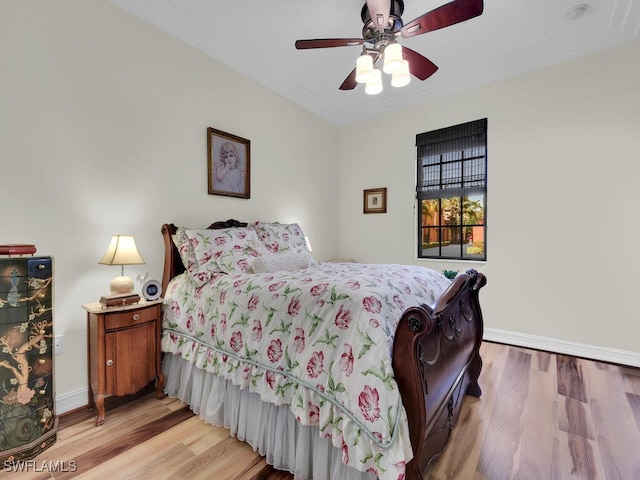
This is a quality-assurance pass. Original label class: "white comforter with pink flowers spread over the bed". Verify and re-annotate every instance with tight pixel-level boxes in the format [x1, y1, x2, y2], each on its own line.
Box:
[162, 263, 450, 480]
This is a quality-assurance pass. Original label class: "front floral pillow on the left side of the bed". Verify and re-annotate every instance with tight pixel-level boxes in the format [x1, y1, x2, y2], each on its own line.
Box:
[186, 227, 266, 273]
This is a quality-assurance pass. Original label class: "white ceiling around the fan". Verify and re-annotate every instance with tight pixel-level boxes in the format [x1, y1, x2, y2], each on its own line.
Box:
[110, 0, 640, 125]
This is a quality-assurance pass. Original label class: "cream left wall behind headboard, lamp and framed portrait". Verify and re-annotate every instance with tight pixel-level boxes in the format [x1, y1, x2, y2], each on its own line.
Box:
[0, 0, 338, 409]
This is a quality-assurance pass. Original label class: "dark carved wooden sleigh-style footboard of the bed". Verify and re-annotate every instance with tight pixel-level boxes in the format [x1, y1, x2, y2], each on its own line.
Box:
[393, 270, 486, 480]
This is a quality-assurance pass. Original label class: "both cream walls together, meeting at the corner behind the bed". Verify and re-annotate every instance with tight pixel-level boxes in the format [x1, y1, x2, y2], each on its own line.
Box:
[0, 0, 640, 408]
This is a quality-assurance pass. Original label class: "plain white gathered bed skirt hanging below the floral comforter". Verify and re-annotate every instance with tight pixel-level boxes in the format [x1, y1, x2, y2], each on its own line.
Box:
[162, 353, 377, 480]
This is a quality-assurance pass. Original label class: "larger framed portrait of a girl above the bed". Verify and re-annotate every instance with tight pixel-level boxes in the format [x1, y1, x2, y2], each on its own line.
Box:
[207, 127, 251, 198]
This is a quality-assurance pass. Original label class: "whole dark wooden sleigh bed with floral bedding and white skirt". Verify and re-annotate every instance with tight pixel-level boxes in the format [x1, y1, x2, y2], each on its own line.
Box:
[161, 219, 486, 480]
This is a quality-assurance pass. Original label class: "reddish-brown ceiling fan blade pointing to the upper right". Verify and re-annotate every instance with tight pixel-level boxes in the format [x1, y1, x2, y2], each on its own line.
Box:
[400, 0, 484, 37]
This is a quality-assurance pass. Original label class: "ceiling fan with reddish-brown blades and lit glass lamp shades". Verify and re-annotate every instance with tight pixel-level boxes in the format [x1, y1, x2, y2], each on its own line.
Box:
[295, 0, 484, 93]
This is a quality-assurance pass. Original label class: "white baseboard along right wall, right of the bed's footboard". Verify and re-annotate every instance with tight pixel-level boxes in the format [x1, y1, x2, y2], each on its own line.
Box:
[484, 328, 640, 367]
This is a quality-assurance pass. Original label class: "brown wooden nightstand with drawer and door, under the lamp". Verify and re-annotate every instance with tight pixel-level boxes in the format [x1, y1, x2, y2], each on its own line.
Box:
[82, 299, 164, 426]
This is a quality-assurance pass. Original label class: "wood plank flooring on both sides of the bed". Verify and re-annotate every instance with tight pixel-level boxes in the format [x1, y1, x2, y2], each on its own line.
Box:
[5, 342, 640, 480]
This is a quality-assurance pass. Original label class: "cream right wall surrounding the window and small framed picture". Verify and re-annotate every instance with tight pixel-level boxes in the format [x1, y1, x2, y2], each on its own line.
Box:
[339, 41, 640, 365]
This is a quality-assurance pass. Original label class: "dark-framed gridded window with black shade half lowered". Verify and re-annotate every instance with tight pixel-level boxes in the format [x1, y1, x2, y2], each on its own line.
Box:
[416, 118, 487, 260]
